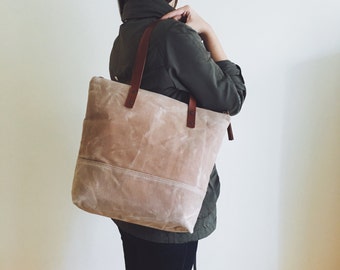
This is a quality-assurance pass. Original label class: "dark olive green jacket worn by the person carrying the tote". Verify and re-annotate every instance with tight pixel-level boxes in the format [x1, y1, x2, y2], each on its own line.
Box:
[110, 0, 246, 243]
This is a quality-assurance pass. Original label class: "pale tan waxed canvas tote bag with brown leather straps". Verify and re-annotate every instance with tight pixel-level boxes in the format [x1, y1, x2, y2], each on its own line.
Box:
[72, 21, 230, 232]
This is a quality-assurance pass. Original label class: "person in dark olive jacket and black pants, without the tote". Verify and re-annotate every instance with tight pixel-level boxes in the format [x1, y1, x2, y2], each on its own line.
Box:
[110, 0, 246, 270]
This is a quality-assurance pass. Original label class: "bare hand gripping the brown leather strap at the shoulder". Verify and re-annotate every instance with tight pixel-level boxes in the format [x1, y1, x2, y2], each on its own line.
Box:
[161, 5, 211, 34]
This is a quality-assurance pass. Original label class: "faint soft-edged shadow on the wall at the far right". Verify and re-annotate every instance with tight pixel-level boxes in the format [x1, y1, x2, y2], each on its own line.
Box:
[279, 53, 340, 270]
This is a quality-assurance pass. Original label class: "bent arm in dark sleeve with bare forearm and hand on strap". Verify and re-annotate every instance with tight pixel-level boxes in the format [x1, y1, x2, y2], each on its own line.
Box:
[163, 6, 246, 115]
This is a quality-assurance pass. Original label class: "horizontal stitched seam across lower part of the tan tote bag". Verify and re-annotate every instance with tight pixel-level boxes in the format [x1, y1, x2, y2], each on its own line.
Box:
[78, 157, 205, 195]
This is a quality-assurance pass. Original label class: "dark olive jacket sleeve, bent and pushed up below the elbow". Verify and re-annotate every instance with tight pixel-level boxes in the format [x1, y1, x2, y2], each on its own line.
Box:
[163, 23, 246, 115]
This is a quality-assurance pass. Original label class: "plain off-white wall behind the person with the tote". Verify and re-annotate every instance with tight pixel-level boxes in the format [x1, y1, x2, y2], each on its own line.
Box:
[0, 0, 340, 270]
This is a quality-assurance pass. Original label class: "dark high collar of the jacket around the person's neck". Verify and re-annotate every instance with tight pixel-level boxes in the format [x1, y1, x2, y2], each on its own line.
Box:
[119, 0, 173, 22]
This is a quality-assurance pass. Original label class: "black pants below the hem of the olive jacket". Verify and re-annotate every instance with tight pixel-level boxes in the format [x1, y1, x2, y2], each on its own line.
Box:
[120, 231, 198, 270]
